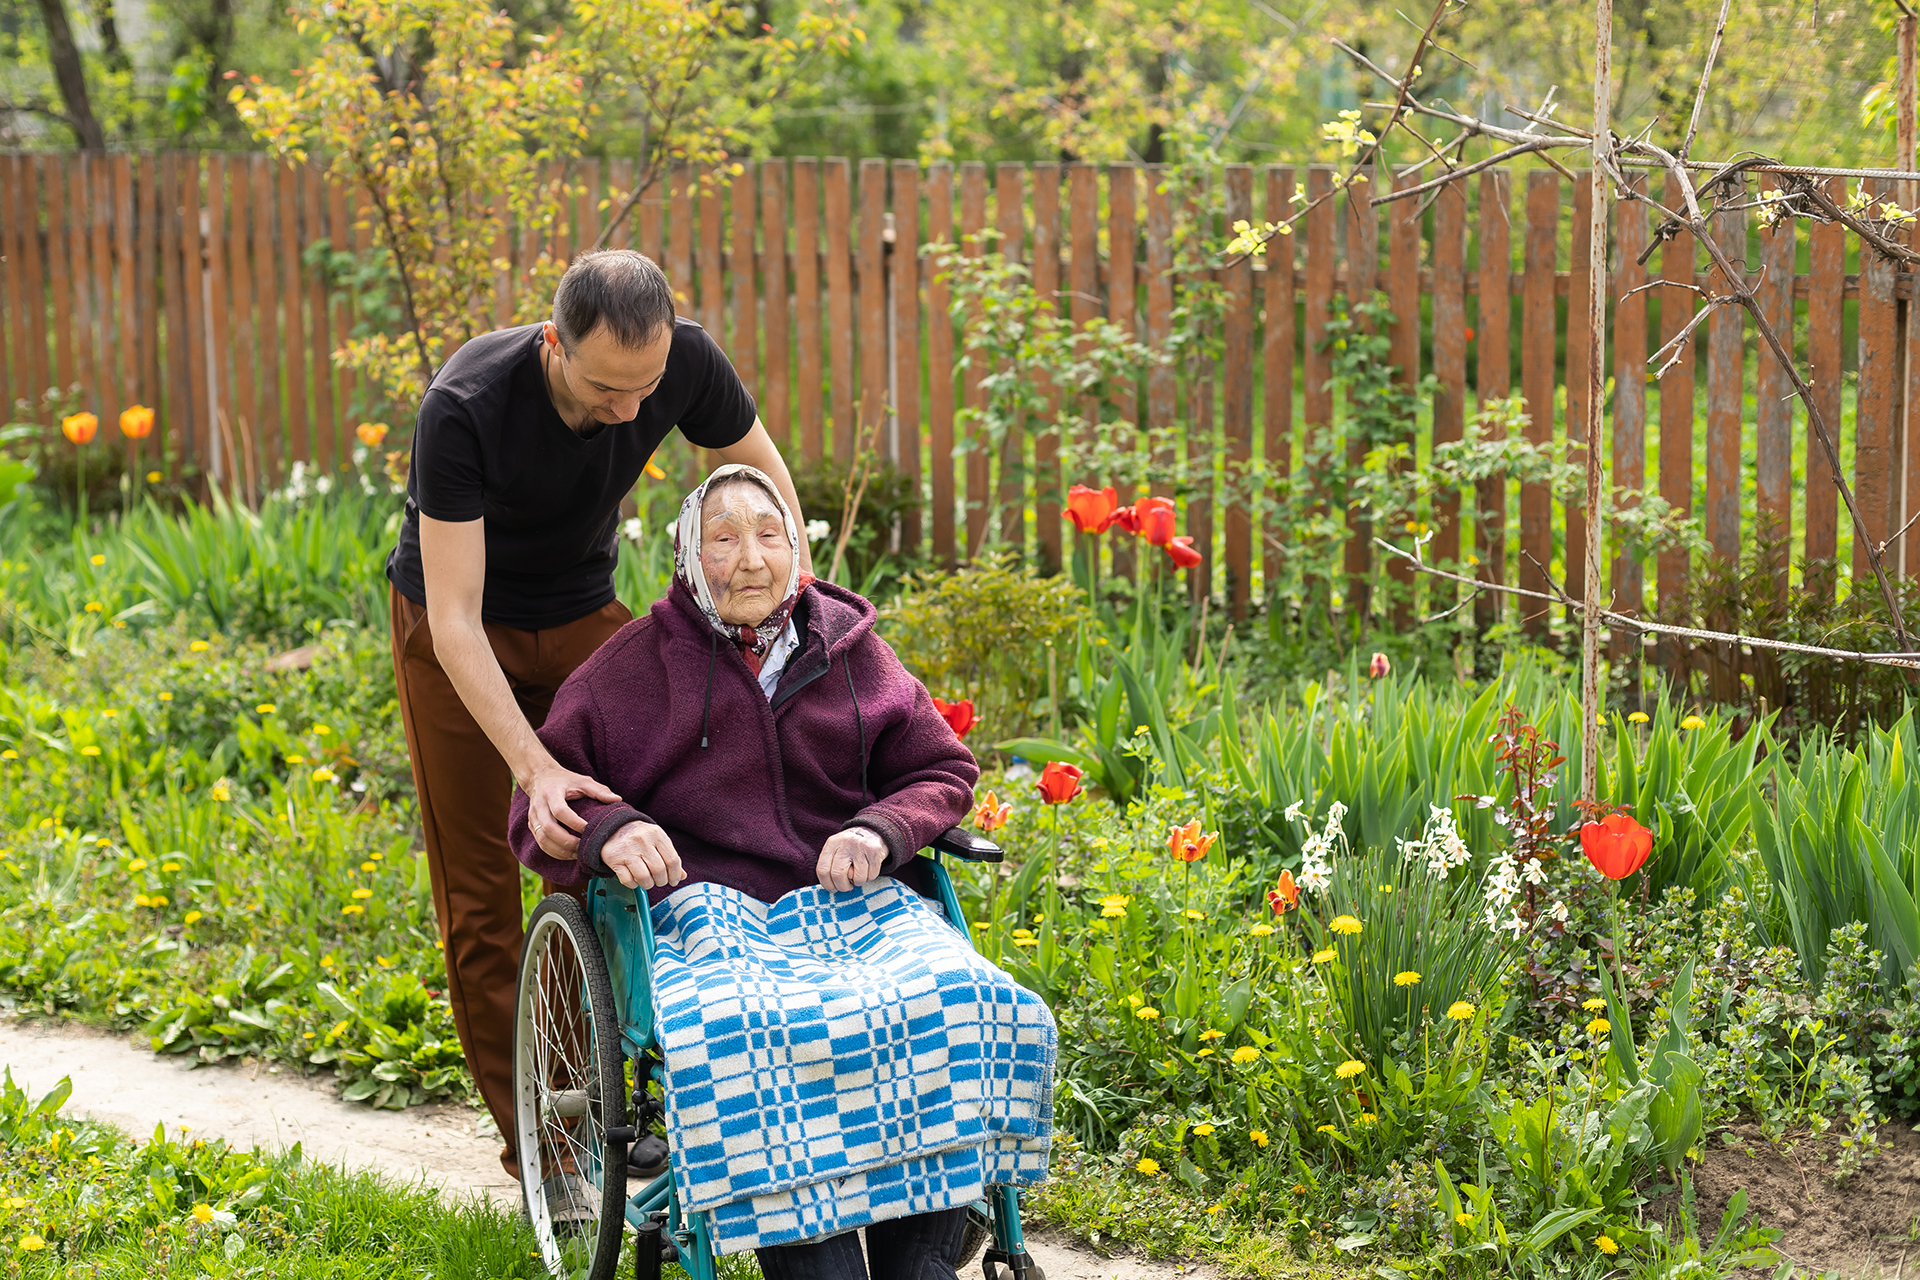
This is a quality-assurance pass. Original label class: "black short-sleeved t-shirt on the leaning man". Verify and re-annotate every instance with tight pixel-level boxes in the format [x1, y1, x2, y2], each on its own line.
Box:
[386, 320, 755, 629]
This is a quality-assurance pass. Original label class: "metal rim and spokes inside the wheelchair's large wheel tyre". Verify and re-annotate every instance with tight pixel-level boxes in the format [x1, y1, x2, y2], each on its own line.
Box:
[515, 913, 605, 1276]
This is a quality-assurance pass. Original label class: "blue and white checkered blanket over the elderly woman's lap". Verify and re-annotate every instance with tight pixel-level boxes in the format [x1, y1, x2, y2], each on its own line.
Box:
[653, 877, 1058, 1255]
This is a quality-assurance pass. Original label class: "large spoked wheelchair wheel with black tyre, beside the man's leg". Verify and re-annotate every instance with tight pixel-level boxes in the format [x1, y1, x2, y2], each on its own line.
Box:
[513, 894, 626, 1280]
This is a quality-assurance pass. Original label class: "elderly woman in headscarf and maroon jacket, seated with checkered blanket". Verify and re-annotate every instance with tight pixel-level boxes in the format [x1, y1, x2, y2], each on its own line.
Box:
[513, 466, 1054, 1280]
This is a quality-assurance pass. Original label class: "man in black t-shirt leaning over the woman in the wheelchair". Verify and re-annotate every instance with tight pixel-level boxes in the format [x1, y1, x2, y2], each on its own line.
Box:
[386, 249, 812, 1176]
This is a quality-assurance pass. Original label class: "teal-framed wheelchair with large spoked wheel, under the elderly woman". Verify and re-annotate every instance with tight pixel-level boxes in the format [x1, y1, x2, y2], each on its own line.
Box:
[513, 827, 1046, 1280]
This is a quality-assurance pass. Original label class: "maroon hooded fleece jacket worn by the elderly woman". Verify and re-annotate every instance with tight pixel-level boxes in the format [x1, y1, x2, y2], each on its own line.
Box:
[511, 581, 979, 902]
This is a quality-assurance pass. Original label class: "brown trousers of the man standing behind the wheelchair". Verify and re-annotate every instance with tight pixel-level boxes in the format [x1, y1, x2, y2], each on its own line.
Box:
[390, 589, 634, 1176]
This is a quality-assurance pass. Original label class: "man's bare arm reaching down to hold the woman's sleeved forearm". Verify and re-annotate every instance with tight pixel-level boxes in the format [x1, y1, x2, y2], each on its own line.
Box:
[420, 514, 614, 858]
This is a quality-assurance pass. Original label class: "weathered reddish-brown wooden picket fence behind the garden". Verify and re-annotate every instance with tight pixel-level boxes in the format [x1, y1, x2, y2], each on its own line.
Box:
[0, 154, 1920, 628]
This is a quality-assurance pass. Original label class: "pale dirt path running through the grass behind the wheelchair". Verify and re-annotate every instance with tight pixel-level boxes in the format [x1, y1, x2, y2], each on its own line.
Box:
[0, 1019, 1217, 1280]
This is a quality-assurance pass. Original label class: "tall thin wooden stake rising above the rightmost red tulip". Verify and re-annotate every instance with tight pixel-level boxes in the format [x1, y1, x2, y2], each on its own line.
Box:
[1580, 0, 1613, 800]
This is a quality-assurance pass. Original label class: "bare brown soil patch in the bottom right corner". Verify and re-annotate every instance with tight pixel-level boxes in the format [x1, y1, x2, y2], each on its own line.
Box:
[1647, 1123, 1920, 1280]
